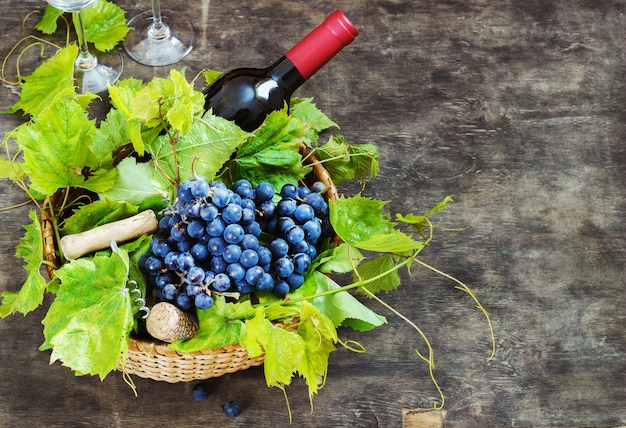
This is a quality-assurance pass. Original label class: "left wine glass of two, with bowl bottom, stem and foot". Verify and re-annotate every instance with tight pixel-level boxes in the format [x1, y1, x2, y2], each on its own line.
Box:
[46, 0, 124, 94]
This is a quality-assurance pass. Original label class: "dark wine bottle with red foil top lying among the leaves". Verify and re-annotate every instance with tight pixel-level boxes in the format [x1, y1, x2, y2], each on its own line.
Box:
[203, 10, 358, 131]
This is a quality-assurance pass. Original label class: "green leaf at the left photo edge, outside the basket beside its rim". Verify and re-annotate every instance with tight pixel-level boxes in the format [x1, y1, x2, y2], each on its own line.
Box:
[0, 210, 46, 318]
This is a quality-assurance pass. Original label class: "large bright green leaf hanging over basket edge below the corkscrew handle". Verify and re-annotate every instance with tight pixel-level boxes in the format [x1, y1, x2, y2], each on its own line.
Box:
[40, 249, 133, 379]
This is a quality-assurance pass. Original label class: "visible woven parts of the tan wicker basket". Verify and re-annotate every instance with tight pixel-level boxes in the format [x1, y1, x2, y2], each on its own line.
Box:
[41, 144, 338, 383]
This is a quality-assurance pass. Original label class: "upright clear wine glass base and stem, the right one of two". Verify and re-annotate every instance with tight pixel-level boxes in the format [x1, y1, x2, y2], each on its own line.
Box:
[124, 0, 191, 66]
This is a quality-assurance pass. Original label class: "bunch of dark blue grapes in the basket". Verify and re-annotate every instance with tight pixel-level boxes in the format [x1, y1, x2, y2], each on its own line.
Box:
[142, 178, 331, 310]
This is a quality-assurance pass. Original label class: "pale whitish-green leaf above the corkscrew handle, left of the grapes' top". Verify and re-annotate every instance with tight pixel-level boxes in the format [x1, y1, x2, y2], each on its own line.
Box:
[100, 157, 167, 205]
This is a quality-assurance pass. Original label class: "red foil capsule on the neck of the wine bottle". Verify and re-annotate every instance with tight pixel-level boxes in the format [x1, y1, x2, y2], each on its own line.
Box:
[285, 10, 358, 80]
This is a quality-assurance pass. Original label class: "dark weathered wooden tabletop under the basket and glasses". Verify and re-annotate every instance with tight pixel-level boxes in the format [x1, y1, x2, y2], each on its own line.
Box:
[0, 0, 626, 427]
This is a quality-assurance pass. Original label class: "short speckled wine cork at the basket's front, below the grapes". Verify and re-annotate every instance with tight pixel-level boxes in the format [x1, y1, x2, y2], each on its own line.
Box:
[146, 302, 199, 343]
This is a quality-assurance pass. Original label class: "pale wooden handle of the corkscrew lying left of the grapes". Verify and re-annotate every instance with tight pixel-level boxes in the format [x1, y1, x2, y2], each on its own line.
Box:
[60, 210, 159, 260]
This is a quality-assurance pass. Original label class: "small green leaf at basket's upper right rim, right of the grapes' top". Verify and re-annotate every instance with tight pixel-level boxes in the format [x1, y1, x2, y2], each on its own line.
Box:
[315, 135, 378, 184]
